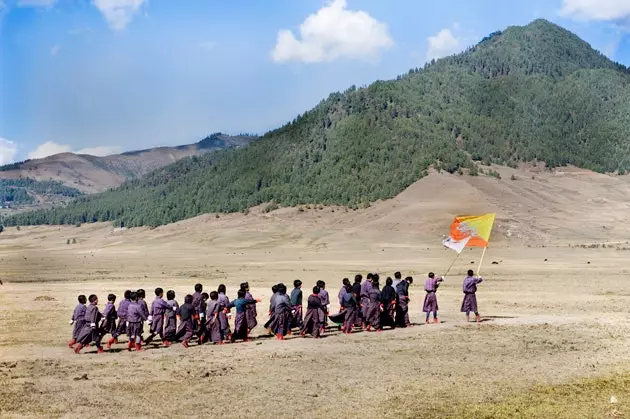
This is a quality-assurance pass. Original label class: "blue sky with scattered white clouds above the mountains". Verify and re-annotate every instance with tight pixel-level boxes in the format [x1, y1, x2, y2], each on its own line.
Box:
[0, 0, 630, 164]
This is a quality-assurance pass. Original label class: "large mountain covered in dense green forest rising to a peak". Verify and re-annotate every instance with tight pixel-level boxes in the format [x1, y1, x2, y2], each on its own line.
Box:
[6, 20, 630, 230]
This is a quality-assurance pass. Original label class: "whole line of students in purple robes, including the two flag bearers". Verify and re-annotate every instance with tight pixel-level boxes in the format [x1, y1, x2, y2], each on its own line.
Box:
[68, 271, 483, 354]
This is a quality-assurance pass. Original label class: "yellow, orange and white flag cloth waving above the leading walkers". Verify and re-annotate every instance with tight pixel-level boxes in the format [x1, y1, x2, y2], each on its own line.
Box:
[442, 213, 496, 253]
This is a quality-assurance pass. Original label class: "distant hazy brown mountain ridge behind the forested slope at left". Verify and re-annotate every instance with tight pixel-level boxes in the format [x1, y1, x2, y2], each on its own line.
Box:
[0, 133, 256, 204]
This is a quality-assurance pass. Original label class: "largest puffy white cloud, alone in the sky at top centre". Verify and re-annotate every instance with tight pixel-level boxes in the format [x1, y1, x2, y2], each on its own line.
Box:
[271, 0, 394, 63]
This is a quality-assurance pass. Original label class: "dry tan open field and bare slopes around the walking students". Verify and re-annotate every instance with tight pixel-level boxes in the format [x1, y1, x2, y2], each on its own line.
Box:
[0, 169, 630, 418]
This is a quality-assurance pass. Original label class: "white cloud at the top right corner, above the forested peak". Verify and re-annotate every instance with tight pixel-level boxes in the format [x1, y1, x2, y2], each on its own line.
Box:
[560, 0, 630, 21]
